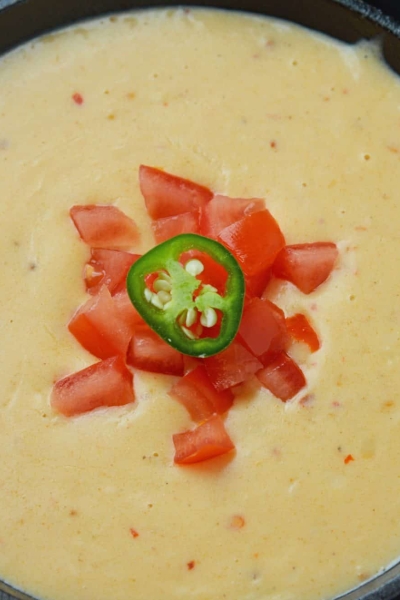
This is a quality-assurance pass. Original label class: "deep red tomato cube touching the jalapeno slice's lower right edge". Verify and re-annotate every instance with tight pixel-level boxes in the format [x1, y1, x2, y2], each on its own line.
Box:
[204, 340, 262, 391]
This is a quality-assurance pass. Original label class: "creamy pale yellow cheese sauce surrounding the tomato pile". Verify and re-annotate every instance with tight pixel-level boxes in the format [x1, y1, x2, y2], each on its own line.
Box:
[0, 10, 400, 600]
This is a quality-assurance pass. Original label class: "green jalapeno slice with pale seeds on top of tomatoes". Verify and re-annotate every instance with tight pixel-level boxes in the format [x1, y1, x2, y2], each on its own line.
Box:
[127, 233, 245, 358]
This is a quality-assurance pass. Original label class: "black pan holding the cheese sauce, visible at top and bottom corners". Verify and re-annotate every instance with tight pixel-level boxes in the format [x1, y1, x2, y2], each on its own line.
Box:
[0, 0, 400, 600]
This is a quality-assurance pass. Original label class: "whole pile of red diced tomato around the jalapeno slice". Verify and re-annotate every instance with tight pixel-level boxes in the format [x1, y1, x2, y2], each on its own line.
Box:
[51, 166, 338, 464]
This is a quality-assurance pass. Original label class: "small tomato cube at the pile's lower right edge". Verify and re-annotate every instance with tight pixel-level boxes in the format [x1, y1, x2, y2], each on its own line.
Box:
[257, 352, 307, 402]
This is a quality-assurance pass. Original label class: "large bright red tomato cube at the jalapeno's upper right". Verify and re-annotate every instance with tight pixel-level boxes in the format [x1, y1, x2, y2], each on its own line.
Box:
[218, 209, 285, 275]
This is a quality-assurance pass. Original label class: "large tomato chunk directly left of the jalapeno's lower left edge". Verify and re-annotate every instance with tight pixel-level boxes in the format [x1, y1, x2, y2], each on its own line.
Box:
[68, 286, 133, 358]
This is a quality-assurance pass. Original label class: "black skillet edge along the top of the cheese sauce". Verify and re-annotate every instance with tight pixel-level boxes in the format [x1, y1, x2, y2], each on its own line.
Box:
[0, 0, 400, 58]
